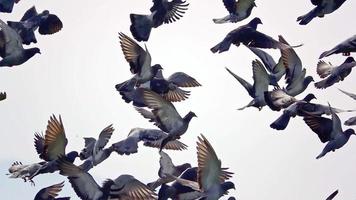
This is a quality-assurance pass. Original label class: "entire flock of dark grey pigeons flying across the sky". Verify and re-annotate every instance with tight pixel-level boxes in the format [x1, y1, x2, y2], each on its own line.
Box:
[0, 0, 356, 200]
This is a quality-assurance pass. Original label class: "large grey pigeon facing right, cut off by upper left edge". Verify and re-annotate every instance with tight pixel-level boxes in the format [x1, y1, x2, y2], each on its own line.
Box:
[0, 20, 41, 67]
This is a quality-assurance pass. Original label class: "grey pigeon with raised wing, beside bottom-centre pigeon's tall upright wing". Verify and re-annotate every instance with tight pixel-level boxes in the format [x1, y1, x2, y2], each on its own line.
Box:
[147, 151, 192, 190]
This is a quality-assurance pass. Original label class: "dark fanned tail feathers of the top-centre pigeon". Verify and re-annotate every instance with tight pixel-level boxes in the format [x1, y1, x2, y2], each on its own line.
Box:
[130, 14, 152, 42]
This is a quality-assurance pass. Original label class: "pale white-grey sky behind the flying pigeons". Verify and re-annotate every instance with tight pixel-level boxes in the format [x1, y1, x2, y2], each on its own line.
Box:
[0, 0, 356, 200]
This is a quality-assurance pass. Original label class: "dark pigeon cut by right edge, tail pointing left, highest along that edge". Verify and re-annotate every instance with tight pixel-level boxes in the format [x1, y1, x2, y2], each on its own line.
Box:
[319, 35, 356, 59]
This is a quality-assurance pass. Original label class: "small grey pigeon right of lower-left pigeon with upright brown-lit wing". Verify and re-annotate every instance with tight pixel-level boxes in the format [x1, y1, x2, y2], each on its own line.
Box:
[79, 124, 114, 170]
